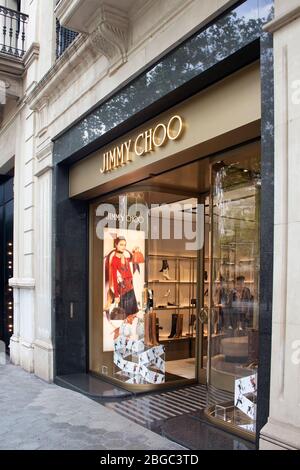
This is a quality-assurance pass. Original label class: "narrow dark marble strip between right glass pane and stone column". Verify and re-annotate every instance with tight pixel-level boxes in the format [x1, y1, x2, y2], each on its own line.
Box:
[257, 34, 274, 443]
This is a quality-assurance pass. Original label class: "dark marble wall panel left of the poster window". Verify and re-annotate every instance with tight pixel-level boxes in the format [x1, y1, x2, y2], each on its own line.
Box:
[53, 166, 88, 375]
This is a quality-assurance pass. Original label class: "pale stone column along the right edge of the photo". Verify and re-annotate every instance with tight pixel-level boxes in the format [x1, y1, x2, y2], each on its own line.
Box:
[260, 0, 300, 450]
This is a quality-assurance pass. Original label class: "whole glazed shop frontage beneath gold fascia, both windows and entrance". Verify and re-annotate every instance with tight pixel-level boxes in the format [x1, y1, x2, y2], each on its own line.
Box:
[90, 141, 261, 435]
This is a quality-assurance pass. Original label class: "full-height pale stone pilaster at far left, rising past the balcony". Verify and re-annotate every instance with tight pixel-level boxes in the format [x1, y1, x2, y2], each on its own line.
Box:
[9, 0, 39, 372]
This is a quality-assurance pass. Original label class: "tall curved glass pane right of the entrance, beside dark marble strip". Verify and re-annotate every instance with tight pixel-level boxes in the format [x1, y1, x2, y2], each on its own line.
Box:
[207, 146, 261, 436]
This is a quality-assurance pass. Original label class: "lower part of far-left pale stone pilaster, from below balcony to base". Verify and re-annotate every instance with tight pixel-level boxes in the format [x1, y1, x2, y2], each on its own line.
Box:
[9, 105, 35, 372]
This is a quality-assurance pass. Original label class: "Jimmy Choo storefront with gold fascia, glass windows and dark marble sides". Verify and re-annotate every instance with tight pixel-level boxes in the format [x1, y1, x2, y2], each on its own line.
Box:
[53, 0, 272, 448]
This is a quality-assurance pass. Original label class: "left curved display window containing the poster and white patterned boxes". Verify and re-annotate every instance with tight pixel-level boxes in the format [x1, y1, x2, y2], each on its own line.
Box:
[90, 188, 197, 386]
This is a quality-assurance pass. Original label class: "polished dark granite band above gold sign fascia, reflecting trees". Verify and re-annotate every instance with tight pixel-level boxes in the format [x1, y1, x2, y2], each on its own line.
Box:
[55, 0, 273, 161]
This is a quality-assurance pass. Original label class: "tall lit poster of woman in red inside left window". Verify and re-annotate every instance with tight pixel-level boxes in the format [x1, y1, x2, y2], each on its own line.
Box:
[103, 228, 145, 352]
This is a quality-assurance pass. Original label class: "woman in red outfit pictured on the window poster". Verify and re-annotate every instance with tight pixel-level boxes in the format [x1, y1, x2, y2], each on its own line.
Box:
[105, 237, 139, 317]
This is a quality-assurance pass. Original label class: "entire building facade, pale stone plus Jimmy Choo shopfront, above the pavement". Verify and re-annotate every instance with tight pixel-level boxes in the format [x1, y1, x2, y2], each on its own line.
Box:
[0, 0, 300, 449]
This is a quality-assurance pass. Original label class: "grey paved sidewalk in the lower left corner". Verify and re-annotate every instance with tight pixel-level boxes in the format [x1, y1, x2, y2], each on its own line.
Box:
[0, 364, 182, 450]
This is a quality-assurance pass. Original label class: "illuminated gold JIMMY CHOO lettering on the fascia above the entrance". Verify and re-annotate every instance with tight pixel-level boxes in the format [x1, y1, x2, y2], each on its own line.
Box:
[100, 115, 184, 173]
